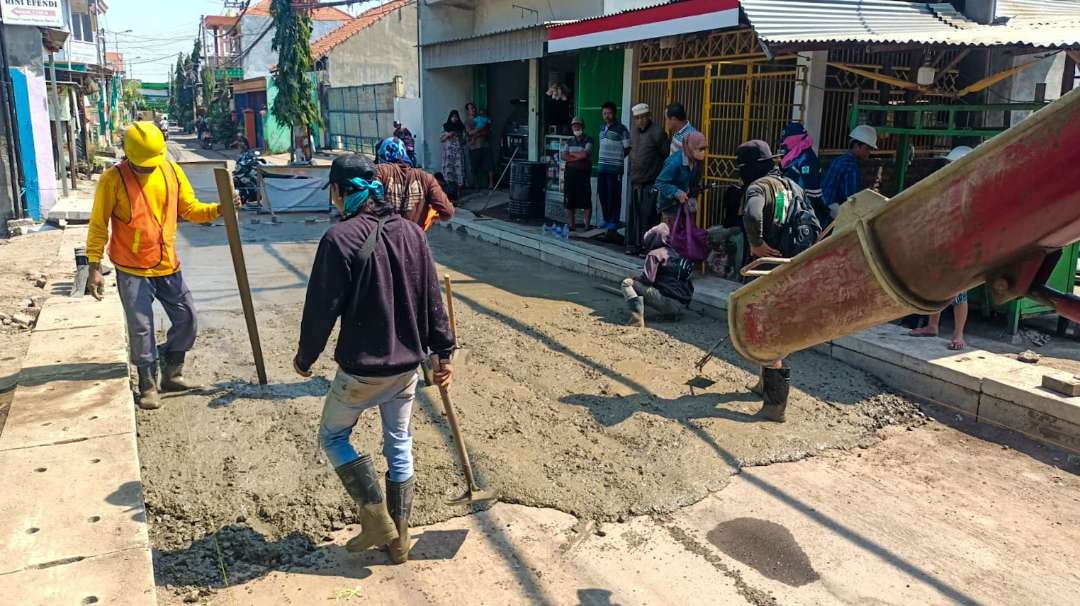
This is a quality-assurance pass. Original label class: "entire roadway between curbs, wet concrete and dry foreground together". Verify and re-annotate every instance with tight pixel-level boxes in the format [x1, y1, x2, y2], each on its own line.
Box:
[122, 215, 1080, 604]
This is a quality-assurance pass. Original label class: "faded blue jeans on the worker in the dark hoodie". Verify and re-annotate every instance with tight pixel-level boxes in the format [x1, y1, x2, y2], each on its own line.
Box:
[319, 368, 417, 482]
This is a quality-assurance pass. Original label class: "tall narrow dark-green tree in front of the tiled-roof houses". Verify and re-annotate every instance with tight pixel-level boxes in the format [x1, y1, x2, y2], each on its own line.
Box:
[270, 0, 321, 127]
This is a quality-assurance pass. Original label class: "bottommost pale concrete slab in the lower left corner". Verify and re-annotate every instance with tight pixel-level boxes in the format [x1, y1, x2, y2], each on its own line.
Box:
[0, 548, 157, 606]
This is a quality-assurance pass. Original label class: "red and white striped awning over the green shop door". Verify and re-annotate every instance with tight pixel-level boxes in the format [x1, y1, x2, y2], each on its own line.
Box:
[548, 0, 739, 53]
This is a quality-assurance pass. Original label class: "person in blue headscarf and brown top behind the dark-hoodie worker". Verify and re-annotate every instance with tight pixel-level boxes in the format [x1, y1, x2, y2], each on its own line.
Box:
[375, 137, 454, 231]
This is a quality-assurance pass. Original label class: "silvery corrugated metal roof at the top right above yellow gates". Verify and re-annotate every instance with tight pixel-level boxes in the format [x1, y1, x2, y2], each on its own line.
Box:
[742, 0, 1080, 48]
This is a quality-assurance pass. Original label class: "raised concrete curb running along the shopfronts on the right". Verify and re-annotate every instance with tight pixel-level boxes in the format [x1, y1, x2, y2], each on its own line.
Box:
[441, 210, 1080, 450]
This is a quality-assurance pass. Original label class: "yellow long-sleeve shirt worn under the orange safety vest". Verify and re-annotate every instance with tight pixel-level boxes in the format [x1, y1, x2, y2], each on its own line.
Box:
[86, 158, 221, 278]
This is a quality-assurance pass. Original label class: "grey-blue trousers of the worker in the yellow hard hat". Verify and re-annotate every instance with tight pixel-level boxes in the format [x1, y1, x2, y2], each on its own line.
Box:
[117, 269, 199, 366]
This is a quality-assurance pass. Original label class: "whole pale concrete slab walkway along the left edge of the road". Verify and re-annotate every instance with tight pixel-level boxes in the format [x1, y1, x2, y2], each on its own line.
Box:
[0, 229, 157, 605]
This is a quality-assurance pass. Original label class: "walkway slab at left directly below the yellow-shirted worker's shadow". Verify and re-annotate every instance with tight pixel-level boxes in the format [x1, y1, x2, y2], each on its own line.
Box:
[0, 375, 135, 450]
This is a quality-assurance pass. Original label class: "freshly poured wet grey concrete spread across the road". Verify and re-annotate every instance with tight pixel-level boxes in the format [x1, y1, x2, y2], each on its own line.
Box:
[138, 219, 923, 585]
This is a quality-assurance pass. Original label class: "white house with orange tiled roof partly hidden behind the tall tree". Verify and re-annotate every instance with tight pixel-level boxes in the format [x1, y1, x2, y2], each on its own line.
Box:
[239, 0, 352, 79]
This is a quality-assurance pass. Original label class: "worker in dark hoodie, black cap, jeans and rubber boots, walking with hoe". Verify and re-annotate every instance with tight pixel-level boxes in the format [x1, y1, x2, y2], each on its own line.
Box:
[293, 154, 454, 563]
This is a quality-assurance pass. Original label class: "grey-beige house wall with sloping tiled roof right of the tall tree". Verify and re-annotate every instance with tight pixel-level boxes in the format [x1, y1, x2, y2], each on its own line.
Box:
[311, 0, 420, 92]
